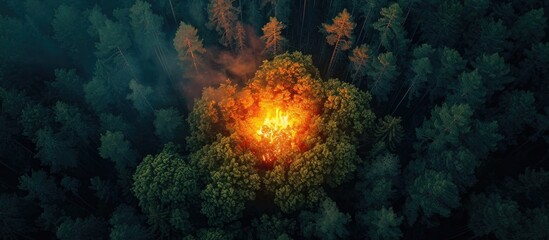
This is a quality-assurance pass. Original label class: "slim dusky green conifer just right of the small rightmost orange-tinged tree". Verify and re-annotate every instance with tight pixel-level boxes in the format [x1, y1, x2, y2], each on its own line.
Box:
[366, 52, 398, 102]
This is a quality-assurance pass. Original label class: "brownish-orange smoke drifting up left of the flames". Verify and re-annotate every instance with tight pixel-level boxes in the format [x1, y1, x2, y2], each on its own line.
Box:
[181, 23, 264, 109]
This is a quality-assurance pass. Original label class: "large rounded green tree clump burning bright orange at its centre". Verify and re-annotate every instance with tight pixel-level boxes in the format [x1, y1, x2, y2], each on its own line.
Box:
[187, 52, 375, 222]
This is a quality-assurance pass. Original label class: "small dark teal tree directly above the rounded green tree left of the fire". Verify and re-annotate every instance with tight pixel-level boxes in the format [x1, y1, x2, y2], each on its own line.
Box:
[154, 108, 183, 142]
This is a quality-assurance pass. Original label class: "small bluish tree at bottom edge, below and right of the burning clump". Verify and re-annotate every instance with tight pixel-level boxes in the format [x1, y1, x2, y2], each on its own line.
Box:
[358, 207, 403, 240]
